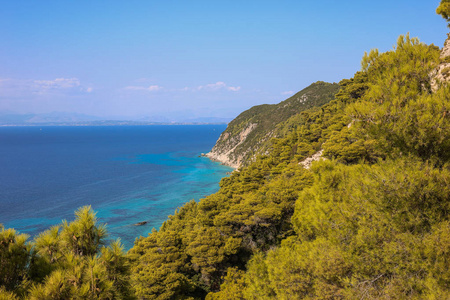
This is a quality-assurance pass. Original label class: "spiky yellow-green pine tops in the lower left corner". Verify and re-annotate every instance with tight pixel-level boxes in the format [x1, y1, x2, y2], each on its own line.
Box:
[0, 207, 135, 300]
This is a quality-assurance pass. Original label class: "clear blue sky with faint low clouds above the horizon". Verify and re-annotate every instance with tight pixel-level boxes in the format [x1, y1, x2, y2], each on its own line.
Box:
[0, 0, 449, 121]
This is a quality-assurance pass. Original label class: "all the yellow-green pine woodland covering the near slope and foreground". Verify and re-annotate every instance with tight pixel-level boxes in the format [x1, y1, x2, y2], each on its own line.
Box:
[0, 1, 450, 299]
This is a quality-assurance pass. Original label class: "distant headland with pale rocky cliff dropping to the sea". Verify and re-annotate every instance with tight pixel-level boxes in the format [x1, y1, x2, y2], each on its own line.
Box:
[206, 81, 339, 168]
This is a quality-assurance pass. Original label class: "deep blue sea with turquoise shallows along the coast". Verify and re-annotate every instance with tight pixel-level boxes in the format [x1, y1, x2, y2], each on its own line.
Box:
[0, 125, 232, 249]
